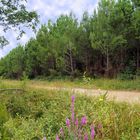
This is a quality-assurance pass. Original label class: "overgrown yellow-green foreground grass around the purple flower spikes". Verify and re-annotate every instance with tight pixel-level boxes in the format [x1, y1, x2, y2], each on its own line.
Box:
[0, 81, 140, 140]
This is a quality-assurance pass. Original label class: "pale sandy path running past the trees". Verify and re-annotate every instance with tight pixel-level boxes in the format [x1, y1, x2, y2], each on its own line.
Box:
[30, 85, 140, 103]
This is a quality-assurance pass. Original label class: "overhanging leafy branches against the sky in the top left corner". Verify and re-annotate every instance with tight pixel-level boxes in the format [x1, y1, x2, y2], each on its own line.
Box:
[0, 0, 38, 47]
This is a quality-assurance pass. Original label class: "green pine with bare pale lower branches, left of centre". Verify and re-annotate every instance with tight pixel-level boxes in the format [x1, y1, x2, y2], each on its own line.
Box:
[49, 14, 78, 76]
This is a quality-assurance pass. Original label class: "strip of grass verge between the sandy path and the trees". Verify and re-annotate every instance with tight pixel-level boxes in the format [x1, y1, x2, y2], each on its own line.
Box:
[3, 79, 140, 91]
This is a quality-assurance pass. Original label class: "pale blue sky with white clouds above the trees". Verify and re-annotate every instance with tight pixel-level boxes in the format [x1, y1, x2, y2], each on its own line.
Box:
[0, 0, 99, 58]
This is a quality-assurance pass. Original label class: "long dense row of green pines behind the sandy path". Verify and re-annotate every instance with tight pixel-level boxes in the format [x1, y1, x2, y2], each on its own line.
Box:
[0, 0, 140, 78]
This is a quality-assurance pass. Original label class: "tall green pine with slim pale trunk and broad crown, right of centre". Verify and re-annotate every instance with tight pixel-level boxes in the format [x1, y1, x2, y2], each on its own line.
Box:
[90, 0, 126, 76]
